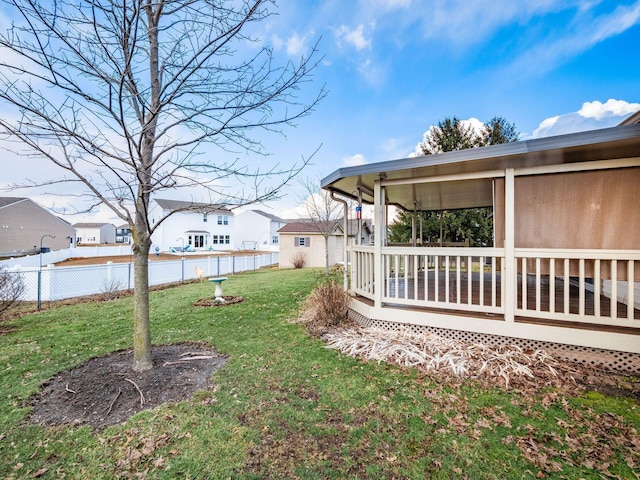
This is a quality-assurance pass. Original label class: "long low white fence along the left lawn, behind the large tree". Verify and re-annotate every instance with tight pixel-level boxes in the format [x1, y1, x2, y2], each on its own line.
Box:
[3, 253, 279, 303]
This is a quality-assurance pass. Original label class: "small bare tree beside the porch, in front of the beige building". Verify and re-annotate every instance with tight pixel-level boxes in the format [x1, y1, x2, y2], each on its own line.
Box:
[298, 179, 348, 273]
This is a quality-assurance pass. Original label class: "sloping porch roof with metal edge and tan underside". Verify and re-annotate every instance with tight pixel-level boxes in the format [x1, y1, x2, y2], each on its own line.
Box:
[321, 124, 640, 210]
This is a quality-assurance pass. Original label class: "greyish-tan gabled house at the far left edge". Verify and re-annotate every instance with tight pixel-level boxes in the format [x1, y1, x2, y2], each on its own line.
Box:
[0, 197, 75, 257]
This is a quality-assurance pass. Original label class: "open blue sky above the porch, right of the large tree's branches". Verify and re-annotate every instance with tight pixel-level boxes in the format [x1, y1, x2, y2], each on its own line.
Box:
[2, 0, 640, 222]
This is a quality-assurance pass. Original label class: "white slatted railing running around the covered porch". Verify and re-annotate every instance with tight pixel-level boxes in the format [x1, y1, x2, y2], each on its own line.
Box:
[351, 246, 640, 328]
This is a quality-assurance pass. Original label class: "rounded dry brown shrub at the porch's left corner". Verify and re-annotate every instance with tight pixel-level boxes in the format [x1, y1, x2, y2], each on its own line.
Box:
[300, 279, 350, 337]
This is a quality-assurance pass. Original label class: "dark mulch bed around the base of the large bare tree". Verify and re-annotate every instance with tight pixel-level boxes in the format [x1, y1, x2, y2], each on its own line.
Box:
[29, 343, 226, 430]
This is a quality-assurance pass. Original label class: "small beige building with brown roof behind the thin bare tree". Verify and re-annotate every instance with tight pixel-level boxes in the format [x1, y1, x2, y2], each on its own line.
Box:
[278, 219, 372, 268]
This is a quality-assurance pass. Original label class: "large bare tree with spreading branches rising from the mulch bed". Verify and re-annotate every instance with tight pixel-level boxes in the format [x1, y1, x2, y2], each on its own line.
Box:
[0, 0, 325, 370]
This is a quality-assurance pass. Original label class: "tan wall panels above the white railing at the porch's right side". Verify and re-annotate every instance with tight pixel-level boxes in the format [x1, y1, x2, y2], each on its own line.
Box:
[494, 168, 640, 280]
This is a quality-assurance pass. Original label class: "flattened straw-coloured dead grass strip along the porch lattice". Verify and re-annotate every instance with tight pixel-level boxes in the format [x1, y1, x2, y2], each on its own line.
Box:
[323, 328, 559, 387]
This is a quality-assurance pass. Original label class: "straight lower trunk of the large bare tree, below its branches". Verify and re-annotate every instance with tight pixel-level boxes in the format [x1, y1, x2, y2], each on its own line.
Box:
[132, 227, 153, 372]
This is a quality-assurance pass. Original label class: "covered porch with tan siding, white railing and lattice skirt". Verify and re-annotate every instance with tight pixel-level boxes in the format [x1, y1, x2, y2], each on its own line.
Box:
[322, 122, 640, 372]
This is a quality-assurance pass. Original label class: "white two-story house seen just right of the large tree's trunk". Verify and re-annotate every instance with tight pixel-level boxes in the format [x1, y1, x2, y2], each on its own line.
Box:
[149, 199, 234, 252]
